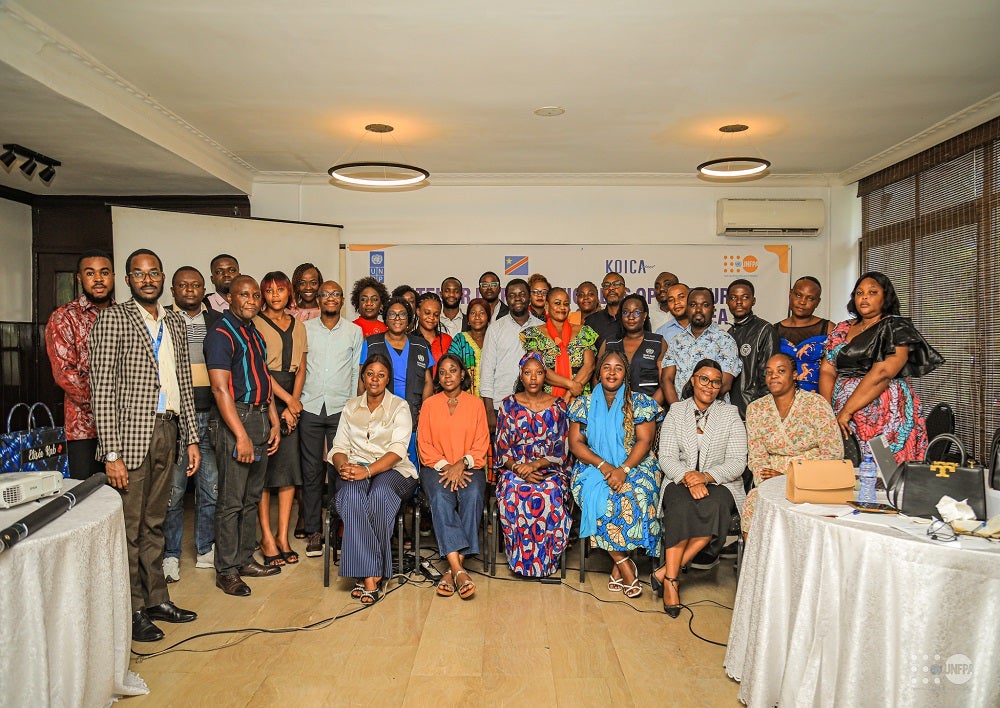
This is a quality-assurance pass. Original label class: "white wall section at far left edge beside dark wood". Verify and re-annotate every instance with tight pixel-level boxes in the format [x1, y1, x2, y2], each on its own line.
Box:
[0, 199, 32, 322]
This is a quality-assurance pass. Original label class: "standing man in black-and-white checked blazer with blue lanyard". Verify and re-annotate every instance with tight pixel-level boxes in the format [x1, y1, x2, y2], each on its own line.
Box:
[91, 248, 201, 642]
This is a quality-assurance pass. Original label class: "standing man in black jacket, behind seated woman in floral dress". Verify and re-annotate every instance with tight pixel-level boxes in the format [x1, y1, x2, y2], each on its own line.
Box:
[726, 278, 781, 420]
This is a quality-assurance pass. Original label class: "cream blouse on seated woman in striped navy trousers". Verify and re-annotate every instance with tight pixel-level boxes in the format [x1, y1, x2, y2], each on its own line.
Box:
[326, 390, 417, 479]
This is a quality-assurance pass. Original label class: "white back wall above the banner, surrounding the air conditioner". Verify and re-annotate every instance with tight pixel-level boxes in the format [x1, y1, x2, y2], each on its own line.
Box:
[251, 177, 860, 318]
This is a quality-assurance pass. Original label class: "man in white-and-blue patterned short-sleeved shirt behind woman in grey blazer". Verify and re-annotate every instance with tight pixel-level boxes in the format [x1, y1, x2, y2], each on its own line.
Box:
[660, 288, 743, 404]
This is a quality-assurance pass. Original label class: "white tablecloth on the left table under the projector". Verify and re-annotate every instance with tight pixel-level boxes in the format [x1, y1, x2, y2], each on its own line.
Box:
[0, 479, 148, 706]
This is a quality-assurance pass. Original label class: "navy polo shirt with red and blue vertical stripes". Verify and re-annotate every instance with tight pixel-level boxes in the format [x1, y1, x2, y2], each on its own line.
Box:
[205, 310, 271, 406]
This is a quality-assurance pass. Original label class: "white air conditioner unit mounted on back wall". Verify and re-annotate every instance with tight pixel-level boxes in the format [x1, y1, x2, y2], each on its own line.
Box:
[716, 199, 826, 236]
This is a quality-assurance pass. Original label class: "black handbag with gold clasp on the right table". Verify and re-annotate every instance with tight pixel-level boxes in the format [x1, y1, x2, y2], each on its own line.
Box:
[887, 433, 986, 520]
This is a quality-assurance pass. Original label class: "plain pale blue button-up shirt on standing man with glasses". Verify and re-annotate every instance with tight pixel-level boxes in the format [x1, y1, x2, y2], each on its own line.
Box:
[300, 317, 364, 415]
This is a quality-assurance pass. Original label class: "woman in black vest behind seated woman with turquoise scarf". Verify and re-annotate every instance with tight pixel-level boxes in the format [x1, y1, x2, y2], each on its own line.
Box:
[597, 293, 667, 406]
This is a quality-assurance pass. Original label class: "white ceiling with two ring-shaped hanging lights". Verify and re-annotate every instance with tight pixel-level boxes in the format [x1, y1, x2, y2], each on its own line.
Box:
[0, 0, 1000, 194]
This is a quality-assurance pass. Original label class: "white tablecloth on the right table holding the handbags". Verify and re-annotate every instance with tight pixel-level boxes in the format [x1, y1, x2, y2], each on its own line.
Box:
[725, 477, 1000, 708]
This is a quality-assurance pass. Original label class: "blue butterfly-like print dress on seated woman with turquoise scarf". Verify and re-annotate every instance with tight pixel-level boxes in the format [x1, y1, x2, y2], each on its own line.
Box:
[569, 387, 663, 557]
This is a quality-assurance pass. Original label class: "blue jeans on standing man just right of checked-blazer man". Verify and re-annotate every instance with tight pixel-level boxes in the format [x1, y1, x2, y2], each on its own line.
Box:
[163, 411, 219, 558]
